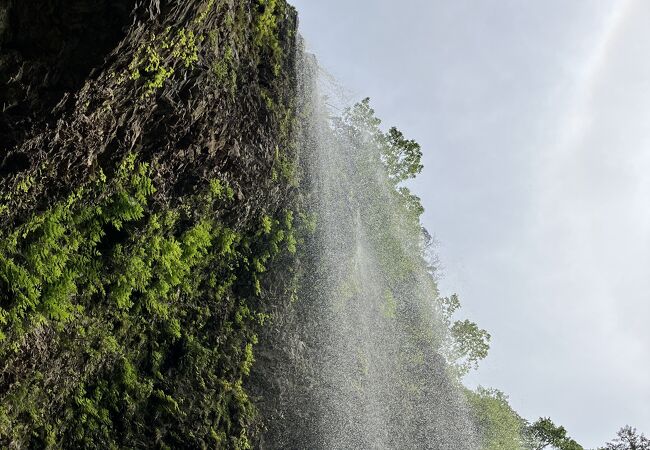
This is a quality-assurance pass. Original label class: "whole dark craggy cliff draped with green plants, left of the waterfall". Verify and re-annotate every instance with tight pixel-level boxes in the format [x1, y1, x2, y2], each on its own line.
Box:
[0, 0, 300, 448]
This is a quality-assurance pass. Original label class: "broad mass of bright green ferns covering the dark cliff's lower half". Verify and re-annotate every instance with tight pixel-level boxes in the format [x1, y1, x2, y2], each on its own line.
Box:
[0, 148, 295, 449]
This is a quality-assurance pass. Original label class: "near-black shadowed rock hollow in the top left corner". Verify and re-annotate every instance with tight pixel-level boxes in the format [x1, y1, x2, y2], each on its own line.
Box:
[0, 0, 133, 155]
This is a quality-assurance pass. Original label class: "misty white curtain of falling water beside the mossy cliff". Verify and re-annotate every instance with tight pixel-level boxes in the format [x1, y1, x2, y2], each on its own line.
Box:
[251, 44, 478, 449]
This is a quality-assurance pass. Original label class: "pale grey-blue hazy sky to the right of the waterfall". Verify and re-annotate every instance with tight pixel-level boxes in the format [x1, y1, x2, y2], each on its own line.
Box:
[290, 0, 650, 448]
